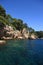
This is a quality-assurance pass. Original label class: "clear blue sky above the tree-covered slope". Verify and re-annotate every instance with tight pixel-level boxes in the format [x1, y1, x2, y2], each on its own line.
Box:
[0, 0, 43, 31]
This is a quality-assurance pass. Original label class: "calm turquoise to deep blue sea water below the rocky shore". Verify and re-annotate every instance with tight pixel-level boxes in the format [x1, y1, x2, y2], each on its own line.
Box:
[0, 39, 43, 65]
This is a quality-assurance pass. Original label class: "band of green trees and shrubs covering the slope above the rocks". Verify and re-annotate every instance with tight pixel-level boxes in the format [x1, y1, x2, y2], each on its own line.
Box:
[0, 5, 43, 39]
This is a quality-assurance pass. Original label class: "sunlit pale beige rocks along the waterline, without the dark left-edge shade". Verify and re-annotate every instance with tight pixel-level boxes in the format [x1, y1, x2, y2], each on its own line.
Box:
[2, 25, 38, 40]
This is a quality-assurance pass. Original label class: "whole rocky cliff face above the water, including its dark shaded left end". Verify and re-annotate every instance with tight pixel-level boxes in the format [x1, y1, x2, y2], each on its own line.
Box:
[0, 23, 37, 39]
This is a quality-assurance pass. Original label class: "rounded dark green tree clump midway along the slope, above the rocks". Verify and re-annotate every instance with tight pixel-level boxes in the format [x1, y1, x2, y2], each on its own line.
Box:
[12, 19, 28, 30]
